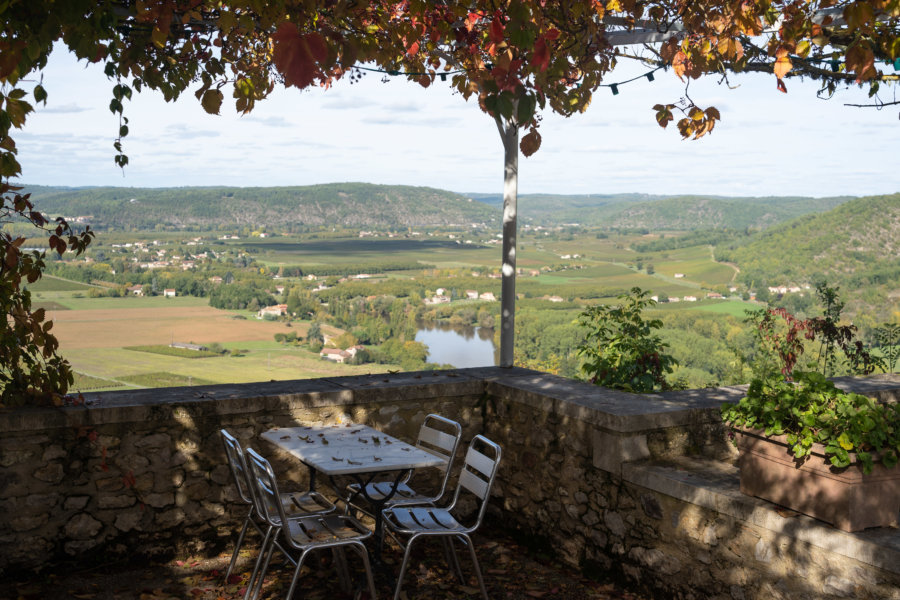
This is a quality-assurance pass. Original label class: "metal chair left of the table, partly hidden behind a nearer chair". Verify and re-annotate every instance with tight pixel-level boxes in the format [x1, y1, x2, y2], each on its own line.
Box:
[219, 429, 335, 580]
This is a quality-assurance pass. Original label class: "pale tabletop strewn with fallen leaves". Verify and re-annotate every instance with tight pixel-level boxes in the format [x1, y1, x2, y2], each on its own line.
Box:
[260, 424, 446, 476]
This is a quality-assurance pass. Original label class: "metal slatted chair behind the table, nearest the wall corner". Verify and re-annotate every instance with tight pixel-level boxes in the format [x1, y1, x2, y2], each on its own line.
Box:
[346, 415, 462, 517]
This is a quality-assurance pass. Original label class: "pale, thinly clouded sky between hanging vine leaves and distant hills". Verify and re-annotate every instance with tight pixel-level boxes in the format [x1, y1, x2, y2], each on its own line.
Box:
[14, 48, 900, 197]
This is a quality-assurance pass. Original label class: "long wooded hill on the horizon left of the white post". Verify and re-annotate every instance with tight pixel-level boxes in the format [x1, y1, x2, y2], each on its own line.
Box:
[26, 183, 500, 230]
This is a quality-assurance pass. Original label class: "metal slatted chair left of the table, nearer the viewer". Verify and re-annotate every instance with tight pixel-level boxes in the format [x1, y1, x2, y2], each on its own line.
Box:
[244, 448, 375, 600]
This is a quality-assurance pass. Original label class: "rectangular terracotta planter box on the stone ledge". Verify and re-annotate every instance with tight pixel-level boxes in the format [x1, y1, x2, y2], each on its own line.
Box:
[737, 430, 900, 531]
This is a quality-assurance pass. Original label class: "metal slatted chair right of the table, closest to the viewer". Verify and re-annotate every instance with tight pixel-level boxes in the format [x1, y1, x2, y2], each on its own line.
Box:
[382, 435, 501, 600]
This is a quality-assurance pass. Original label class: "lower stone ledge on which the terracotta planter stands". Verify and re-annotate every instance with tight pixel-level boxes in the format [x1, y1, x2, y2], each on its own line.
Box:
[622, 458, 900, 574]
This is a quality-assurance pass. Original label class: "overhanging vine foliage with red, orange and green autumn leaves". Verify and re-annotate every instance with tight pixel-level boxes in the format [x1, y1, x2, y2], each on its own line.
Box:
[0, 0, 900, 402]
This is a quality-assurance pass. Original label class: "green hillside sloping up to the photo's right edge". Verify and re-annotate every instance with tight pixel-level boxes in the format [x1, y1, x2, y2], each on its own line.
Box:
[716, 194, 900, 291]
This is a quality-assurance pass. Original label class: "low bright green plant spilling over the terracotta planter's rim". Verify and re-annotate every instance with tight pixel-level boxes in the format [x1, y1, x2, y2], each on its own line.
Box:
[722, 371, 900, 473]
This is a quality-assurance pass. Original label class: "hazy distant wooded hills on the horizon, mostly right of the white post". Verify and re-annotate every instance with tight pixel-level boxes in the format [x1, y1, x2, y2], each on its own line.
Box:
[470, 194, 850, 231]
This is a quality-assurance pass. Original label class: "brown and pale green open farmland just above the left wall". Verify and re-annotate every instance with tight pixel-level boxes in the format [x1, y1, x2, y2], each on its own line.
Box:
[42, 297, 396, 391]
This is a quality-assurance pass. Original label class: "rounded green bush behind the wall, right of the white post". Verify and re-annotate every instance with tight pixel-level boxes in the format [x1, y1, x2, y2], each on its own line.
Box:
[577, 287, 678, 392]
